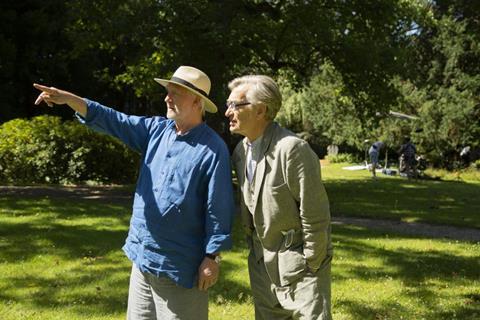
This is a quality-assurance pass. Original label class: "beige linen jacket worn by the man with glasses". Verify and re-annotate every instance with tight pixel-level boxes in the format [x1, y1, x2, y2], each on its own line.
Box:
[232, 122, 333, 286]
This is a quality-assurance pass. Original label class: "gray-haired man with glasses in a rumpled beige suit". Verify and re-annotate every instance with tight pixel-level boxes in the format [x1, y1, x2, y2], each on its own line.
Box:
[225, 75, 332, 320]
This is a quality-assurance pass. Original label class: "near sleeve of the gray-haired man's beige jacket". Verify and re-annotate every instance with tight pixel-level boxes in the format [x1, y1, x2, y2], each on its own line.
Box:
[286, 141, 330, 270]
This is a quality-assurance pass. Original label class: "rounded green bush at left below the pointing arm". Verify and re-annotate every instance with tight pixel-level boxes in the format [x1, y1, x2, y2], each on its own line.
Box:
[0, 116, 139, 183]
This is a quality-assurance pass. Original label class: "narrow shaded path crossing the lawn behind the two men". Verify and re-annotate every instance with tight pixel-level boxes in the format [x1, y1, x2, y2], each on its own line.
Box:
[0, 186, 480, 242]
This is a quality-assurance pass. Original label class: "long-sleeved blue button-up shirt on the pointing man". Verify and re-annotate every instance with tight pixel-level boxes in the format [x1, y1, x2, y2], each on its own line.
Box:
[79, 99, 234, 288]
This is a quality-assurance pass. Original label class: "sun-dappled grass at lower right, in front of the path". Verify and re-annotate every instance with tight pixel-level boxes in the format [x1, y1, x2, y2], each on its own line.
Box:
[332, 225, 480, 320]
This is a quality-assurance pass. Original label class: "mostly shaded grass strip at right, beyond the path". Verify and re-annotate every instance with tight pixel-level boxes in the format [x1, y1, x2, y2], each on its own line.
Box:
[322, 163, 480, 228]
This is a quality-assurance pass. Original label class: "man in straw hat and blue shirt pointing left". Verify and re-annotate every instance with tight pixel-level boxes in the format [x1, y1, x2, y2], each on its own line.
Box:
[34, 66, 234, 319]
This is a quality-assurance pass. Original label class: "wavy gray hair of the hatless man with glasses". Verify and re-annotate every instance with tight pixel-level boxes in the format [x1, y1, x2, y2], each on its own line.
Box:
[228, 75, 282, 120]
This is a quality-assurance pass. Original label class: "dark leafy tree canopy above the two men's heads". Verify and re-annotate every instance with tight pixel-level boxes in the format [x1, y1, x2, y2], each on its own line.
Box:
[0, 0, 430, 125]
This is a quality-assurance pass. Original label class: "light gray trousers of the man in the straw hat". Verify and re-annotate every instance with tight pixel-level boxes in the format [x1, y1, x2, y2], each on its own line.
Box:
[127, 264, 208, 320]
